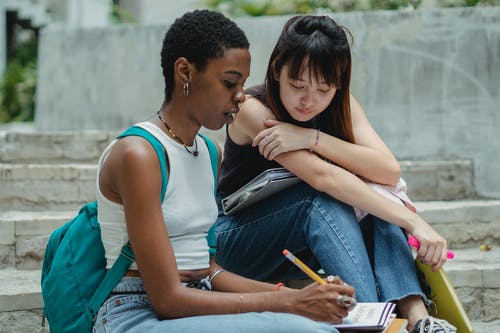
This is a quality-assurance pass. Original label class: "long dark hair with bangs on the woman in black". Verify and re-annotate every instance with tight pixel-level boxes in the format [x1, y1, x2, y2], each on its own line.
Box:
[264, 15, 354, 142]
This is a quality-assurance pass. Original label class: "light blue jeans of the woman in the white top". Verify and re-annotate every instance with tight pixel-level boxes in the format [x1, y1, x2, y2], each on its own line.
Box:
[93, 277, 338, 333]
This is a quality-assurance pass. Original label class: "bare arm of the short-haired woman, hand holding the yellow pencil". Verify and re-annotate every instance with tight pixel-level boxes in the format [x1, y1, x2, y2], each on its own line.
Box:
[99, 137, 354, 322]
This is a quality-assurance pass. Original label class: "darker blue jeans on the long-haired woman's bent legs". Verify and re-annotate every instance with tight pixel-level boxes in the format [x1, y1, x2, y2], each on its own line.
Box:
[216, 183, 425, 302]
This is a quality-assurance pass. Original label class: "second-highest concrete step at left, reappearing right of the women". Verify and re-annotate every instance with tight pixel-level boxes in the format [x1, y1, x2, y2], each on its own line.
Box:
[0, 159, 474, 210]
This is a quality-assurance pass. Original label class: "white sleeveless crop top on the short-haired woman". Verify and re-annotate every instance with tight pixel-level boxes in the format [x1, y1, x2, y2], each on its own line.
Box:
[97, 122, 217, 270]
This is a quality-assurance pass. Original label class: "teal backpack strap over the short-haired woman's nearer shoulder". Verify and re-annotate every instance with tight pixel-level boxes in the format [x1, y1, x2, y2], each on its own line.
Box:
[88, 126, 168, 319]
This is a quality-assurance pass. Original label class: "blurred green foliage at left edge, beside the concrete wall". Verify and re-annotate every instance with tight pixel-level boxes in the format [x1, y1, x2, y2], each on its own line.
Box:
[0, 37, 38, 123]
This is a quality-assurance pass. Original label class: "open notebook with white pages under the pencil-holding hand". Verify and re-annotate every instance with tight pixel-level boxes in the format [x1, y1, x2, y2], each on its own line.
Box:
[333, 302, 396, 331]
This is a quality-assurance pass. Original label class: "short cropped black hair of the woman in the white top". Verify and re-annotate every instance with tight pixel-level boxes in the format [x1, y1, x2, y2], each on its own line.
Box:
[161, 9, 249, 102]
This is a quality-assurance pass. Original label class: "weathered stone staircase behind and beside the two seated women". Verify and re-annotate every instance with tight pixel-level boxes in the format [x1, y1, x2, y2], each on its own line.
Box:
[0, 130, 500, 333]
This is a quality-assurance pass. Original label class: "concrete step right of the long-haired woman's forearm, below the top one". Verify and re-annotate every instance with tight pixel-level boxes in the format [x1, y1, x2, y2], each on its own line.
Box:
[415, 199, 500, 249]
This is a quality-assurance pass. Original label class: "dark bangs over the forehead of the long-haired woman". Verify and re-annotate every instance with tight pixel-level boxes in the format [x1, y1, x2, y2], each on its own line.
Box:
[286, 32, 350, 89]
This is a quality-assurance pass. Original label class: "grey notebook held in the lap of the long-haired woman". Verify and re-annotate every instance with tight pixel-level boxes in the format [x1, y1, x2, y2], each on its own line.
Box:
[222, 168, 300, 215]
